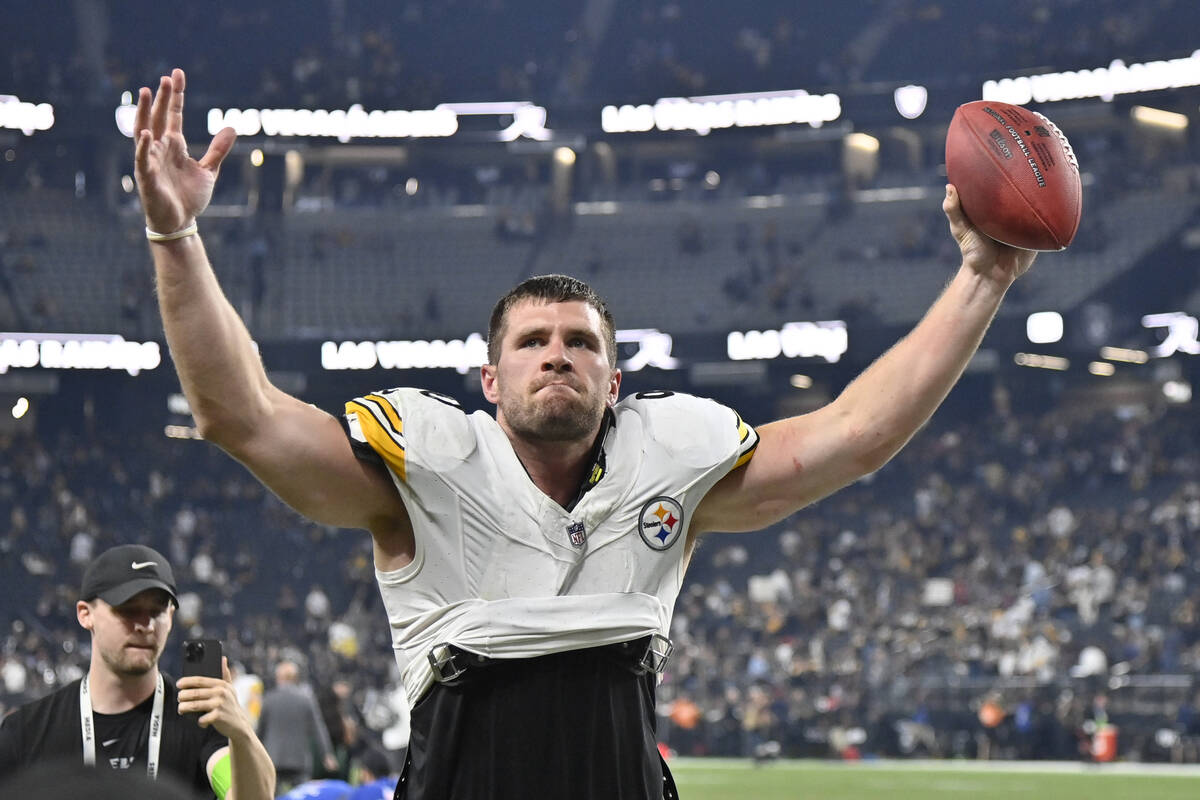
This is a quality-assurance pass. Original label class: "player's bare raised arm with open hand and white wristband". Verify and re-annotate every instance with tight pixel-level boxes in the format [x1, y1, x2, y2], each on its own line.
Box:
[134, 70, 407, 531]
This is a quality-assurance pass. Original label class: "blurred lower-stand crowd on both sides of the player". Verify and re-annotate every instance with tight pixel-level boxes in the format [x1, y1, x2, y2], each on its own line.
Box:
[0, 390, 1200, 758]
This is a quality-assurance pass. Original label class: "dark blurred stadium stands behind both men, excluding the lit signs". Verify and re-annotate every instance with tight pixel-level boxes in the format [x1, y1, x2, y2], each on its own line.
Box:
[0, 0, 1200, 762]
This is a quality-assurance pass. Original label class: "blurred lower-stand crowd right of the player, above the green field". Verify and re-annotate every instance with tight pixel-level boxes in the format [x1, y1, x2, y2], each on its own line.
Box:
[661, 399, 1200, 758]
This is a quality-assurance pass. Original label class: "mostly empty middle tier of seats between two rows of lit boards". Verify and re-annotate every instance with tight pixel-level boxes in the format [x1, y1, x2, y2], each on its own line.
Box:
[7, 163, 1198, 339]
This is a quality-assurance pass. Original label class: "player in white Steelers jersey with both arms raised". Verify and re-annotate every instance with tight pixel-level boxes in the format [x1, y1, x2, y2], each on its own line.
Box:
[136, 70, 1033, 800]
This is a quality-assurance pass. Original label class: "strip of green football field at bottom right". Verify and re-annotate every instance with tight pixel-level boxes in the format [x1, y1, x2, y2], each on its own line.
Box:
[671, 758, 1200, 800]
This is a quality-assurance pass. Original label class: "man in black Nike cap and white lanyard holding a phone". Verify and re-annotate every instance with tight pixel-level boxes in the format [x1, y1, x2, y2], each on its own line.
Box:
[0, 545, 275, 800]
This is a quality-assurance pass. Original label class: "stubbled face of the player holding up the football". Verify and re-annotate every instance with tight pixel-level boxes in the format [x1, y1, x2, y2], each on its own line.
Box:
[482, 299, 620, 441]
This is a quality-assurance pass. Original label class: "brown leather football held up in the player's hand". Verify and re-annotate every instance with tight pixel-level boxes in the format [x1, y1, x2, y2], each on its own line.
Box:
[946, 100, 1084, 251]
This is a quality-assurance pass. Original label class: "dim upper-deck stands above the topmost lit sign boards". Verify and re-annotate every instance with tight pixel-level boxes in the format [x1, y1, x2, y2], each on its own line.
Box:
[7, 0, 1198, 108]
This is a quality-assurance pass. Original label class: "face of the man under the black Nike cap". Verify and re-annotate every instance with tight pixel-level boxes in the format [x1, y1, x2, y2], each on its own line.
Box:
[76, 589, 175, 678]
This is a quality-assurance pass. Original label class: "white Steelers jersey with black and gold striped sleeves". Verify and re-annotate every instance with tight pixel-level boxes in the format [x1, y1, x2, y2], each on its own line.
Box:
[346, 389, 758, 703]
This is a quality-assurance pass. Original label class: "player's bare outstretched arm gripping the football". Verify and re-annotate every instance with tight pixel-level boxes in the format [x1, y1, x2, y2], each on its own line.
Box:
[694, 187, 1034, 533]
